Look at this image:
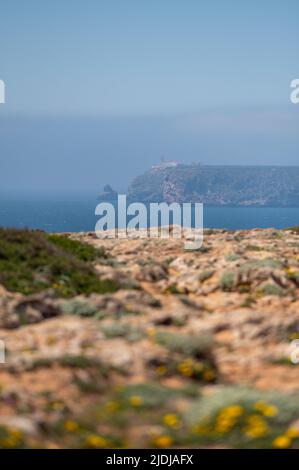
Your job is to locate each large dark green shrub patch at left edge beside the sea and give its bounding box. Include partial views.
[0,228,117,297]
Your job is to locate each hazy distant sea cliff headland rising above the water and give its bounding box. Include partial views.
[128,164,299,207]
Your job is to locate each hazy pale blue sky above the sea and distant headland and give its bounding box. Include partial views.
[0,0,299,193]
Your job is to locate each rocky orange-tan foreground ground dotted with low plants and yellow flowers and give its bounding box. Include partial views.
[0,229,299,448]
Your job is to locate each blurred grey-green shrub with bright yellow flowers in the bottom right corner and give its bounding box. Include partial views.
[185,386,299,448]
